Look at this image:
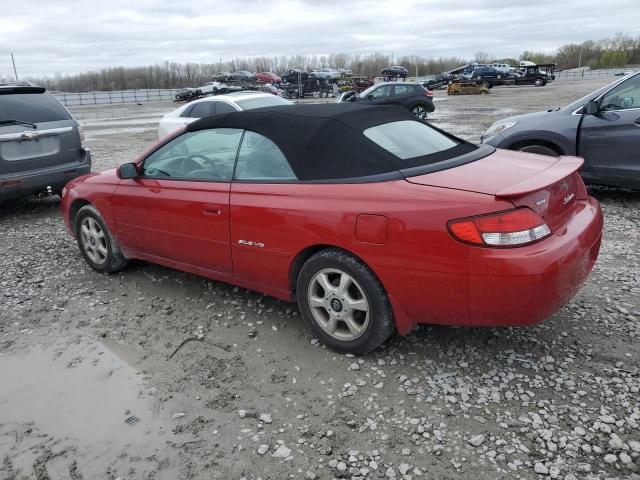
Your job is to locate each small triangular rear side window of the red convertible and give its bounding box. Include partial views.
[235,130,297,182]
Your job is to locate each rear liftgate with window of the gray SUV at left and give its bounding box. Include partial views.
[0,88,81,175]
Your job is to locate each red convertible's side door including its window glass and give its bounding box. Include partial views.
[113,128,243,273]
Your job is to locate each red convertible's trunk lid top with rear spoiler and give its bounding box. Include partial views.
[406,149,583,197]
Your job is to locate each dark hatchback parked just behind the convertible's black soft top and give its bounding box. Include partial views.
[337,82,436,120]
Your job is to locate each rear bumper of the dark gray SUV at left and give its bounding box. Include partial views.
[0,149,91,202]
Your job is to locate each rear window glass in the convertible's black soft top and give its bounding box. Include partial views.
[363,120,461,160]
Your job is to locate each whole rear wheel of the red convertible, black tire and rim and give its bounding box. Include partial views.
[296,248,394,354]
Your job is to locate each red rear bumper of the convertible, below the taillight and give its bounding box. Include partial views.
[468,197,603,326]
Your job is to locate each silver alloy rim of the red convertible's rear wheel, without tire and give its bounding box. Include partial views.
[307,268,370,341]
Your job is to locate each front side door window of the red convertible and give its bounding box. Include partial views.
[143,129,242,182]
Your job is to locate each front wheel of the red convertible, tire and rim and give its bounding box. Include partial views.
[75,205,127,273]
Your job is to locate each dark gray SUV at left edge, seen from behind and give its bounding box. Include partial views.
[0,84,91,202]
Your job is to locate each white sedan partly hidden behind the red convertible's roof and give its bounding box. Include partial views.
[158,92,293,138]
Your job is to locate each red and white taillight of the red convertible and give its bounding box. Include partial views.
[447,208,551,247]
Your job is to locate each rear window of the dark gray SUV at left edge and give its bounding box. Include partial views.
[0,93,71,123]
